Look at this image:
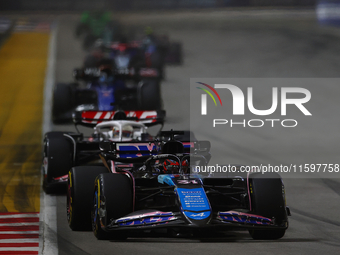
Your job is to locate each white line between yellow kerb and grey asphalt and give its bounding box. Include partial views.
[39,18,58,255]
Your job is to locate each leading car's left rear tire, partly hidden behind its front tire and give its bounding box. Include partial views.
[66,166,108,230]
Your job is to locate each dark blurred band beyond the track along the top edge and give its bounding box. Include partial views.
[0,0,318,11]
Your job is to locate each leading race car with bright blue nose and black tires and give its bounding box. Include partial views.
[67,131,290,239]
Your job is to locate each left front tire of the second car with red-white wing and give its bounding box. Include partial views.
[43,132,73,194]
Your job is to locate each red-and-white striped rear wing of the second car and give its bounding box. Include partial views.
[73,110,166,127]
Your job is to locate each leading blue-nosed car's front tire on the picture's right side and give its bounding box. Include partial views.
[249,173,288,240]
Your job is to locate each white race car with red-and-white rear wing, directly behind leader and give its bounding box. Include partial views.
[42,111,165,193]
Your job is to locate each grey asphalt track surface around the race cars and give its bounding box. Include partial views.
[49,10,340,255]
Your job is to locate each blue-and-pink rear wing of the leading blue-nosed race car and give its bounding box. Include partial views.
[99,141,210,159]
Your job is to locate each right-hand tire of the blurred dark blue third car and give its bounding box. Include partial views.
[140,79,162,110]
